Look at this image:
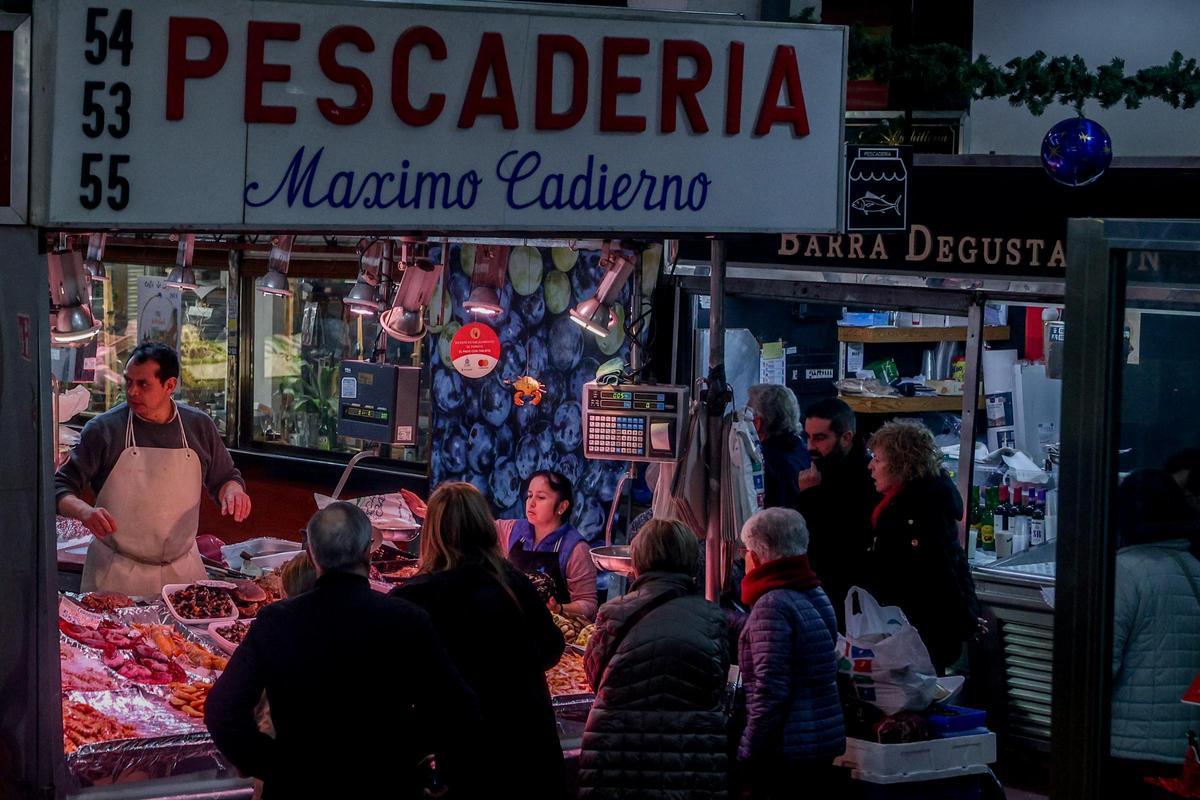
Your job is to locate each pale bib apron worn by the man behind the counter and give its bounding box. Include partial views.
[82,407,205,595]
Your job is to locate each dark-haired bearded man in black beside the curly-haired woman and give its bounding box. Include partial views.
[797,397,880,631]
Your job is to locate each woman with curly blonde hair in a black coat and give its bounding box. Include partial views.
[865,420,979,673]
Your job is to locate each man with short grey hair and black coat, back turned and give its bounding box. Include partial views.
[204,503,479,800]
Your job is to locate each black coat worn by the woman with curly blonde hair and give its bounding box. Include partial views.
[866,473,979,673]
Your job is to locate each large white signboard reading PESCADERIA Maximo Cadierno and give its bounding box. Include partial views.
[35,0,846,234]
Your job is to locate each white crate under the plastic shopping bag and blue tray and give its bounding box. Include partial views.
[834,732,996,780]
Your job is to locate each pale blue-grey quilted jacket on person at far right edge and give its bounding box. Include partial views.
[1111,539,1200,764]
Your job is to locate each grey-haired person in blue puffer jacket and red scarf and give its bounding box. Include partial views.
[738,509,846,800]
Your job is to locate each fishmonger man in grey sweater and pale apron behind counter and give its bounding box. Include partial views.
[54,342,250,595]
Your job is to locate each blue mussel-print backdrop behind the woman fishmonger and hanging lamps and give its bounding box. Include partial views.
[430,245,662,540]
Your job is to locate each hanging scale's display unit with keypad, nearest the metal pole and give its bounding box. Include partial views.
[582,383,688,461]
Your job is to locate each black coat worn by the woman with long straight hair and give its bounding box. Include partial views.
[392,565,566,800]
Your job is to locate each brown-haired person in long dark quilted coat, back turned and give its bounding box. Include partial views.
[578,519,730,800]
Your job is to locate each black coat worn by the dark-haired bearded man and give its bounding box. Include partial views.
[797,441,880,631]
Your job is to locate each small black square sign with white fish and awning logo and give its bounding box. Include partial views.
[846,144,912,231]
